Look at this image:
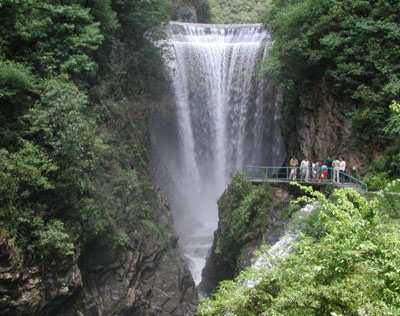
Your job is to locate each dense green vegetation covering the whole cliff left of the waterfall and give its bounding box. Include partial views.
[0,0,177,268]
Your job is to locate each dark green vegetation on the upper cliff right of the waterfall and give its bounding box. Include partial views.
[265,0,400,178]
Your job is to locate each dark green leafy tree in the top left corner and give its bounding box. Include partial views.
[0,0,103,75]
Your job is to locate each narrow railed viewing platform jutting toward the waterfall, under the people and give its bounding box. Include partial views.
[243,166,368,191]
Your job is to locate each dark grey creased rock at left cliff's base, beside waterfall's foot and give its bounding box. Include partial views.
[71,231,197,316]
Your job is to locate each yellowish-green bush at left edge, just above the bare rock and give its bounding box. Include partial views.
[0,140,74,263]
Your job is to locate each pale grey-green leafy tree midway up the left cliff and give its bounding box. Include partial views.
[24,79,96,212]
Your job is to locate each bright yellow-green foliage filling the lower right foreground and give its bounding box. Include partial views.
[197,181,400,316]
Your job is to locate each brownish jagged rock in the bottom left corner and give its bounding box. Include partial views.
[0,239,82,316]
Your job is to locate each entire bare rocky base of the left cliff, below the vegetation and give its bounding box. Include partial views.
[0,192,197,316]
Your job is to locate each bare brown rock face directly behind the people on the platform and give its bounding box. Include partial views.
[285,82,362,175]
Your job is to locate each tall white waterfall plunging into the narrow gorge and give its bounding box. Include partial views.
[155,22,285,284]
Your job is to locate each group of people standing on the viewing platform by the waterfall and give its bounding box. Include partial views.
[289,156,346,183]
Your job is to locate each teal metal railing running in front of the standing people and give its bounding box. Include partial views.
[244,166,368,191]
